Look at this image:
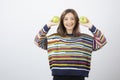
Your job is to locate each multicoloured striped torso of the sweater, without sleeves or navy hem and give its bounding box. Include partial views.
[47,34,93,76]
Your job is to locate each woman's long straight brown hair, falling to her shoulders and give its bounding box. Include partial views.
[57,9,80,37]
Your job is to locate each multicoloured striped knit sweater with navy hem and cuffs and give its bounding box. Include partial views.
[35,25,106,77]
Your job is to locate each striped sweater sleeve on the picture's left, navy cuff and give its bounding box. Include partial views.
[34,25,50,50]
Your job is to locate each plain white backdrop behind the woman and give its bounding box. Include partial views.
[0,0,120,80]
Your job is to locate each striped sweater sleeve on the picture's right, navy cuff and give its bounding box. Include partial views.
[89,25,107,51]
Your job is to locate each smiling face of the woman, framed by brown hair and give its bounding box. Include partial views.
[63,13,76,31]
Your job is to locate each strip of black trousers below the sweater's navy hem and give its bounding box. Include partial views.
[53,76,85,80]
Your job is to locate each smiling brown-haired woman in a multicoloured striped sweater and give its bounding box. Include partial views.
[35,9,106,80]
